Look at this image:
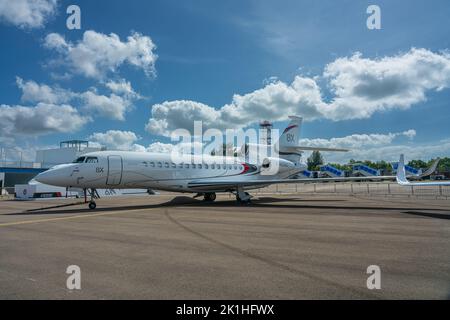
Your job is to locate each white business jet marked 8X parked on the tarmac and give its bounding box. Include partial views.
[35,117,395,209]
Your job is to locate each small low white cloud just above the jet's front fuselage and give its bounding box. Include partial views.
[88,130,139,150]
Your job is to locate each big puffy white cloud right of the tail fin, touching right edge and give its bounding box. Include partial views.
[323,49,450,120]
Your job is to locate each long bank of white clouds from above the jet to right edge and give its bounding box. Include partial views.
[146,49,450,136]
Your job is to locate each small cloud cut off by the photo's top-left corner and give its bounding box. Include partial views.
[0,0,57,29]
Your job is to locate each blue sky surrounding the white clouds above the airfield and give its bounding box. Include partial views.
[0,0,450,161]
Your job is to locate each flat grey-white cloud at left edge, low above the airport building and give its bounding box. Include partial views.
[0,103,90,137]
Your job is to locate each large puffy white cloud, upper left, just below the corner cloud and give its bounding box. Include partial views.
[44,30,158,79]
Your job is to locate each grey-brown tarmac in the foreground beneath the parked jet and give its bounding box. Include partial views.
[0,194,450,299]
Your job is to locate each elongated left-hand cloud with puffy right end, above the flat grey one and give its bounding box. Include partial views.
[17,77,141,121]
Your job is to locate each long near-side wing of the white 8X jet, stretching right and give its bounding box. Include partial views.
[188,176,395,189]
